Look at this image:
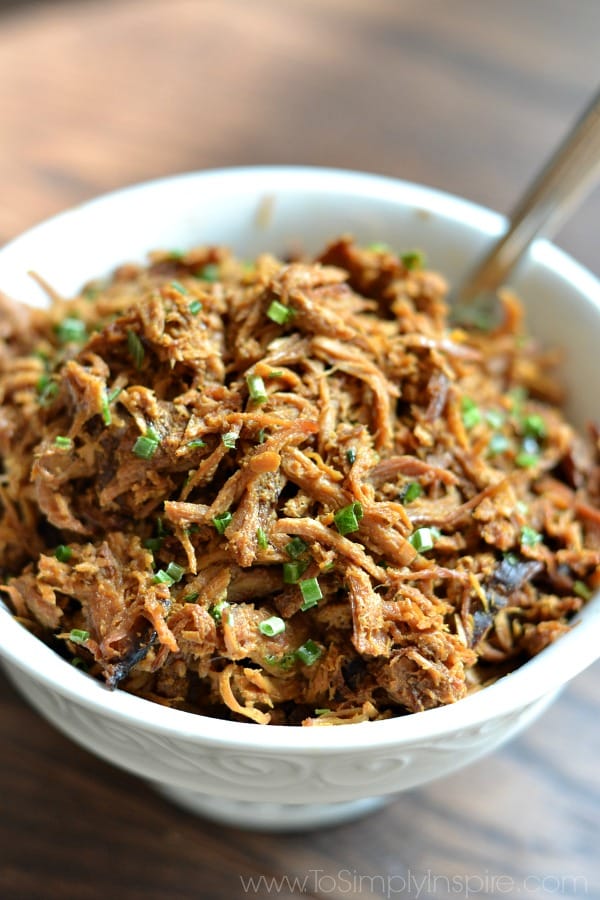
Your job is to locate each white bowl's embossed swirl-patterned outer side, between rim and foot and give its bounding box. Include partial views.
[9,669,554,803]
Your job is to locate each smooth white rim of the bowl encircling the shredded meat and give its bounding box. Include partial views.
[0,165,600,755]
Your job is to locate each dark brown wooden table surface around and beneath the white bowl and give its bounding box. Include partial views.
[0,0,600,900]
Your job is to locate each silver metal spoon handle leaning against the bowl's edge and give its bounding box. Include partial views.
[457,92,600,305]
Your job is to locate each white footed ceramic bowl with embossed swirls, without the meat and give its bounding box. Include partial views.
[0,167,600,829]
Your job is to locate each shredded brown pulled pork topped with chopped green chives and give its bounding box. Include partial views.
[0,239,600,726]
